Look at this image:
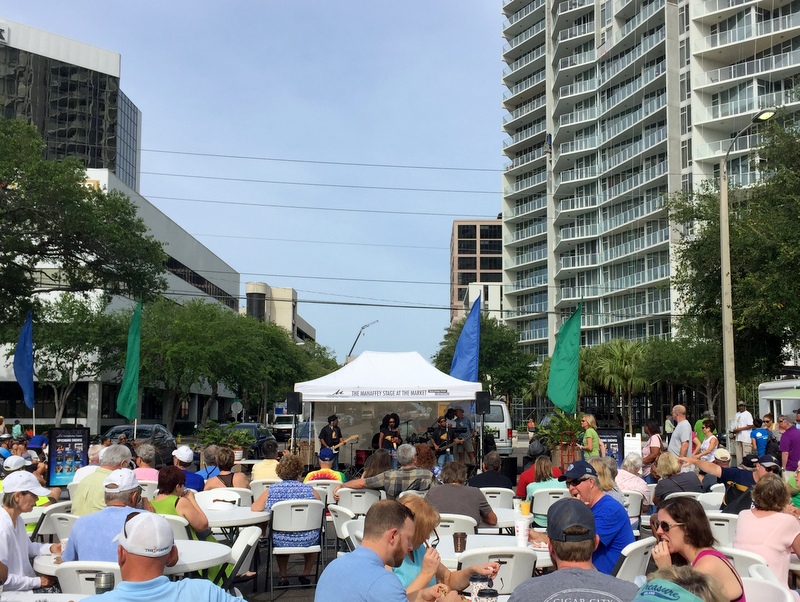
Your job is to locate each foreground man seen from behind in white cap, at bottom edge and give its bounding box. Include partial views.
[86,512,242,602]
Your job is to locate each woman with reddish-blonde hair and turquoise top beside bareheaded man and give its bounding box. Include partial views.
[392,495,500,594]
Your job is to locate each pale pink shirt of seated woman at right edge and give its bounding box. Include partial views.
[733,510,800,600]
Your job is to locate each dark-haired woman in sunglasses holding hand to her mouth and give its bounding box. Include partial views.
[652,497,745,602]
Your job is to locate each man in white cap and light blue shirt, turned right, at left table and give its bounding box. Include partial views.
[61,468,153,562]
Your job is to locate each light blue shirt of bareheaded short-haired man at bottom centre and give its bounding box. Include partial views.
[318,544,410,602]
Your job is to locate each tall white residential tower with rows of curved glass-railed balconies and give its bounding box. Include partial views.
[503,0,800,357]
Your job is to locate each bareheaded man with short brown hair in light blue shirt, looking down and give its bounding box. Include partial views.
[314,500,461,602]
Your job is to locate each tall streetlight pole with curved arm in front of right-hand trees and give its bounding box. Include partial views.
[719,109,776,424]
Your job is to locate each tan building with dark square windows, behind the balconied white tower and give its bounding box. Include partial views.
[450,219,503,324]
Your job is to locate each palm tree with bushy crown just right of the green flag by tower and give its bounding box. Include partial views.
[597,339,647,432]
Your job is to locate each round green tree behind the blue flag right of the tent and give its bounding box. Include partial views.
[432,314,536,401]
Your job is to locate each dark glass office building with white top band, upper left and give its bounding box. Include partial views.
[0,19,141,192]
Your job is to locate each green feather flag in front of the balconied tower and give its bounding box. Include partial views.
[547,301,583,414]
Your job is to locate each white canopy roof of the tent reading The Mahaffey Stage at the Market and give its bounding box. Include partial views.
[294,351,482,402]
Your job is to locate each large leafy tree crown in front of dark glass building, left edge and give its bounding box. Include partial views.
[0,118,166,322]
